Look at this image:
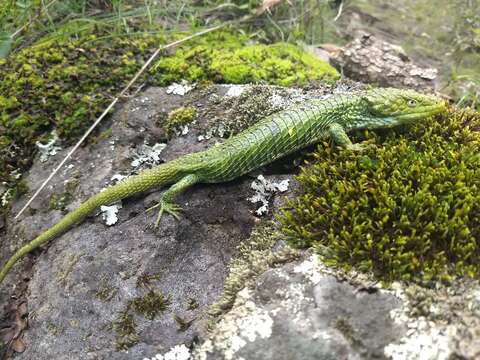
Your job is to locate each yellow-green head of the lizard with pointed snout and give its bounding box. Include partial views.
[362,88,446,127]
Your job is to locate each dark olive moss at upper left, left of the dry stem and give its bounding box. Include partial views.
[0,34,164,187]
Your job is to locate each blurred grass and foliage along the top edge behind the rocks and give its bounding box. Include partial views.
[0,0,480,108]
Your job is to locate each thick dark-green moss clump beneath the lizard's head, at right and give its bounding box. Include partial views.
[279,111,480,282]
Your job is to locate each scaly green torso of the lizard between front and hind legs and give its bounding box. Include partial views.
[198,95,348,183]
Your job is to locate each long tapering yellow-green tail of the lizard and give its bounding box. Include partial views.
[0,160,183,283]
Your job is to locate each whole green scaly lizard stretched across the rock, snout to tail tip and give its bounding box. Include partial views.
[0,88,446,282]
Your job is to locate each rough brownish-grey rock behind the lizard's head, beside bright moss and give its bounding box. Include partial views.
[331,33,438,91]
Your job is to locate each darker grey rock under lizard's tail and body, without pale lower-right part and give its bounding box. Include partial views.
[0,86,322,360]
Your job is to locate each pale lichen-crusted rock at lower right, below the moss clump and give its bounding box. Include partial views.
[191,252,480,360]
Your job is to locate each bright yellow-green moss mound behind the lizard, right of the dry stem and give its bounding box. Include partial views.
[152,31,339,86]
